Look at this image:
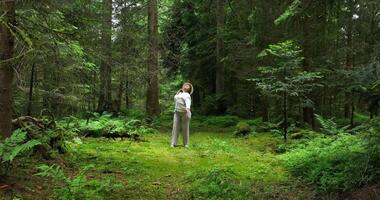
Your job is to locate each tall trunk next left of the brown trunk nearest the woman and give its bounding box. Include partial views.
[98,0,112,112]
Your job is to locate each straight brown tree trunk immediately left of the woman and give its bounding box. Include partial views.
[146,0,160,117]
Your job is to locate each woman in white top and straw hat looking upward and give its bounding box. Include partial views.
[171,83,193,148]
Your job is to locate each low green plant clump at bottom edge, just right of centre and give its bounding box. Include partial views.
[187,168,249,199]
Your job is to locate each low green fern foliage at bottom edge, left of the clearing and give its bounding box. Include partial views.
[36,165,123,200]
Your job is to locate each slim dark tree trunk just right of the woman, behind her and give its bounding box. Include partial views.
[215,0,225,94]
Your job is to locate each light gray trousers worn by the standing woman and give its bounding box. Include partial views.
[172,111,191,145]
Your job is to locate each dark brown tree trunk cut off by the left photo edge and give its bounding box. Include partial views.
[0,1,16,139]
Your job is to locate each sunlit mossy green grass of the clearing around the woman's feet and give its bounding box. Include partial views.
[65,132,314,199]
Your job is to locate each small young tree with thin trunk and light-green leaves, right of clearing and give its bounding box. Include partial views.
[250,40,321,141]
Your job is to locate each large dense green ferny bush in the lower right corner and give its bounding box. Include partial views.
[283,134,380,193]
